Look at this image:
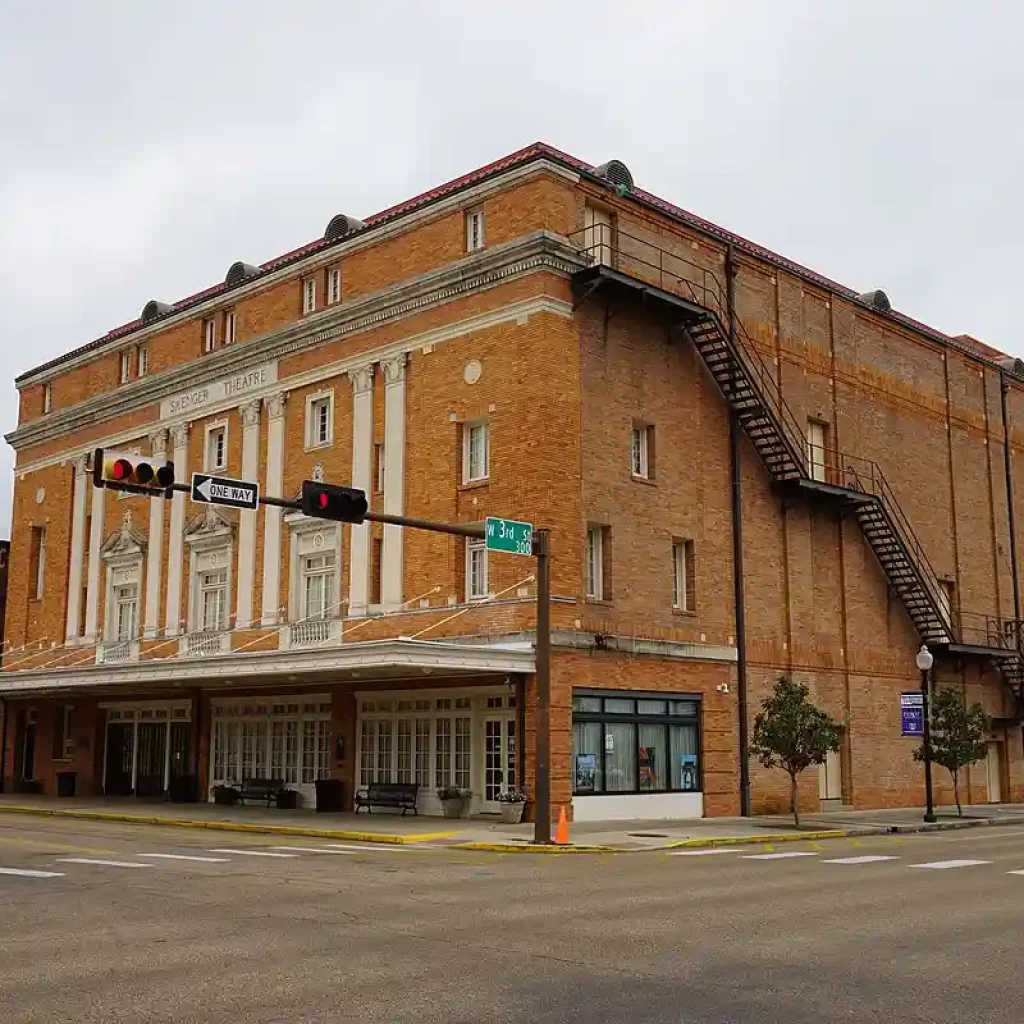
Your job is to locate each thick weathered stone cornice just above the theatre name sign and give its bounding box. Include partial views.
[5,231,589,450]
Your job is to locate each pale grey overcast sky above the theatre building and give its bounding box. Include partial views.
[0,0,1024,536]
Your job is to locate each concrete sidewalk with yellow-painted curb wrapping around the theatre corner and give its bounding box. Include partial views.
[0,795,1024,853]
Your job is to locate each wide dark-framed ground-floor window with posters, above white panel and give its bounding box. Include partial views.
[572,693,700,796]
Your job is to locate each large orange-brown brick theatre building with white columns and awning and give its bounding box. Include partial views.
[0,144,1024,820]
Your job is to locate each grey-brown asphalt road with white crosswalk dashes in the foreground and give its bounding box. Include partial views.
[0,816,1024,1024]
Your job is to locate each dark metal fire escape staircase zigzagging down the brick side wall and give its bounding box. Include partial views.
[573,229,1024,702]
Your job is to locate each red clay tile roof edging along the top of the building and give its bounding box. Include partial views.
[14,142,1009,384]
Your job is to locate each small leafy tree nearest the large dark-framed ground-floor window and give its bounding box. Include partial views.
[750,676,840,827]
